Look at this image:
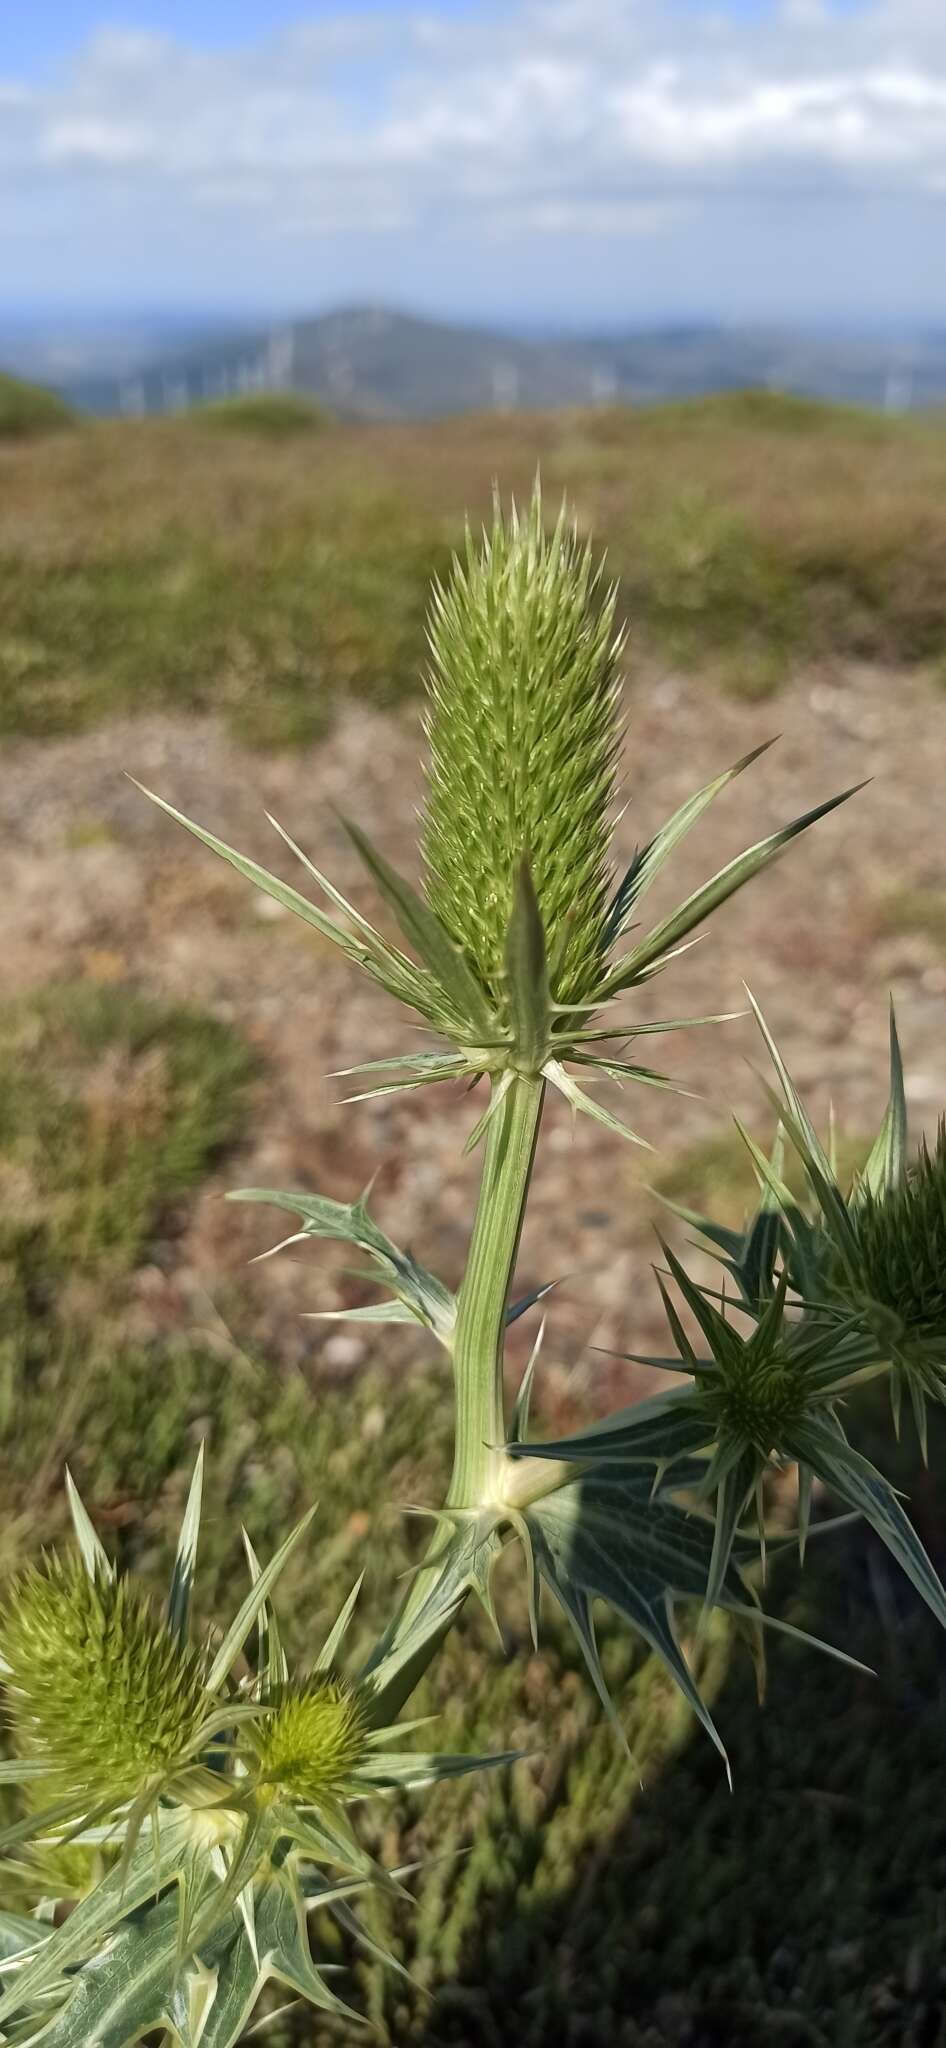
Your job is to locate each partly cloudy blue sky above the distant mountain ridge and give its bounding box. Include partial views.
[0,0,946,328]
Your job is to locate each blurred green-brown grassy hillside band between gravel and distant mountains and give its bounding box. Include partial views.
[0,393,946,745]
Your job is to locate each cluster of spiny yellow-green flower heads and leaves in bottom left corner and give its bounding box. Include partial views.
[0,1458,513,2048]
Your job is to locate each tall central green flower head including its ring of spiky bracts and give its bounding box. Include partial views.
[138,483,852,1143]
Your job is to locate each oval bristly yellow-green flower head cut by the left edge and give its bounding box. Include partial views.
[0,1556,207,1806]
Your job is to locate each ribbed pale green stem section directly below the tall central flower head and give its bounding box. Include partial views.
[446,1075,545,1507]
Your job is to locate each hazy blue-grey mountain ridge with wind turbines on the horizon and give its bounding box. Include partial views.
[24,305,946,420]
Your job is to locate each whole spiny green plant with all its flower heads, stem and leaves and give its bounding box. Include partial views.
[0,471,946,2048]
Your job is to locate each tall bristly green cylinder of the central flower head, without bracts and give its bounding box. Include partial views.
[424,485,620,1004]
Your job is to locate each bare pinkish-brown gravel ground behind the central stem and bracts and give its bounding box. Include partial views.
[0,666,946,1419]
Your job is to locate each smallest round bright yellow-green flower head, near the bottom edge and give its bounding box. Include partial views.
[250,1677,369,1806]
